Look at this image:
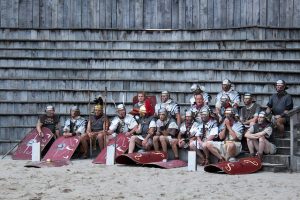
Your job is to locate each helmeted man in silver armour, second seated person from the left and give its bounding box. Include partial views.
[63,106,88,158]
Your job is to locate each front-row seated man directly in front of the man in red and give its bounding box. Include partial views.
[128,105,156,153]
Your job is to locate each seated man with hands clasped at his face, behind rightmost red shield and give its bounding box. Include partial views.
[206,108,244,162]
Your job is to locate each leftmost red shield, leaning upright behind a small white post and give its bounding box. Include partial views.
[12,127,53,160]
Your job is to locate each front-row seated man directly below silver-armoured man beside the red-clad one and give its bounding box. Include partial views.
[153,108,179,159]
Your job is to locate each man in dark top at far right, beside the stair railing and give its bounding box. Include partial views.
[266,80,294,137]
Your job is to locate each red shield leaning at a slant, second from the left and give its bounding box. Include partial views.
[42,136,80,161]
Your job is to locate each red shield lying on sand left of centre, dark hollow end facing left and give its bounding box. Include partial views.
[116,151,167,165]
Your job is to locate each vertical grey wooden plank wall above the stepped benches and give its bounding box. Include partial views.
[0,0,300,29]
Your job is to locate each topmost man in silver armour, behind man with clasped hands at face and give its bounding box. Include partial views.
[216,79,240,112]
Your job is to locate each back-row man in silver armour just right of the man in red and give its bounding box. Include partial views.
[155,91,181,127]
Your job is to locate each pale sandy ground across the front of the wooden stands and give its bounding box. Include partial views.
[0,157,300,200]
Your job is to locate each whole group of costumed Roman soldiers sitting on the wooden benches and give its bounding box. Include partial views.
[36,79,293,165]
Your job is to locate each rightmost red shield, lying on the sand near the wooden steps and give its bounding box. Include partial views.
[204,157,261,175]
